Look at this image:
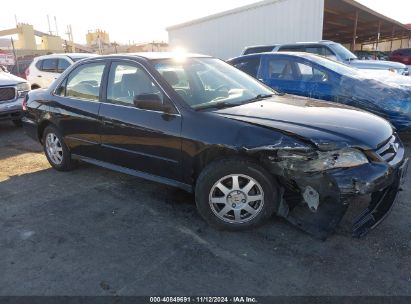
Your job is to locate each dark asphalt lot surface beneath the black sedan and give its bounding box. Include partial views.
[0,123,411,296]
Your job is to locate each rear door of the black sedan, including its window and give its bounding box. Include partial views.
[50,60,106,159]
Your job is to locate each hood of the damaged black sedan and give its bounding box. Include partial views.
[214,95,393,150]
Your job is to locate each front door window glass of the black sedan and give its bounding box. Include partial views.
[107,62,163,106]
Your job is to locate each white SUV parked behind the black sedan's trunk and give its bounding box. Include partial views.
[25,53,97,90]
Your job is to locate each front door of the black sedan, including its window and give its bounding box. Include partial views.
[100,60,182,180]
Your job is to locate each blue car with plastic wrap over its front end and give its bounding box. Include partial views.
[228,53,411,131]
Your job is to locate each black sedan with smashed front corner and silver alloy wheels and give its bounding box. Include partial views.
[23,53,407,239]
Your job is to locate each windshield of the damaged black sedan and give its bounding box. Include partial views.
[153,58,275,109]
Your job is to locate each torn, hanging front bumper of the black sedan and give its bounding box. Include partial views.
[268,141,408,240]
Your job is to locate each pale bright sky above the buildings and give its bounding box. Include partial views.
[0,0,411,43]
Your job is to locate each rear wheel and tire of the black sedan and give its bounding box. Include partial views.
[42,126,75,171]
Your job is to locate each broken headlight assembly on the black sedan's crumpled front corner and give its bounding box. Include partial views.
[270,148,368,173]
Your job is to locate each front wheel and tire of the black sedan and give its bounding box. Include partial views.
[195,159,280,231]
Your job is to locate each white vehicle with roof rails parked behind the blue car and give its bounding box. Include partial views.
[243,40,409,75]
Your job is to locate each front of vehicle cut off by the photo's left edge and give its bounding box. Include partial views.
[0,69,30,126]
